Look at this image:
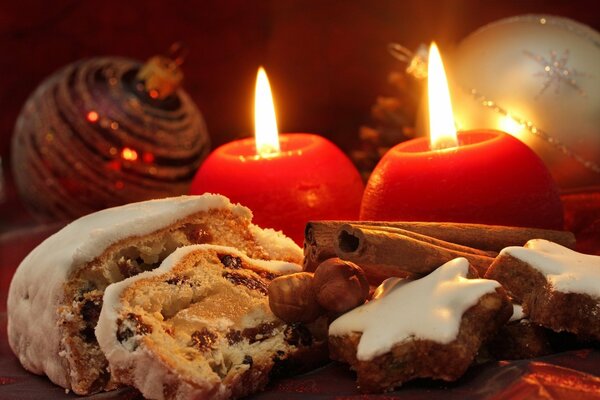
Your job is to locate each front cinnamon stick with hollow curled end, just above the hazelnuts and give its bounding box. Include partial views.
[335,224,494,276]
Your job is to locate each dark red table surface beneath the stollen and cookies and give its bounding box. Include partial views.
[0,224,600,400]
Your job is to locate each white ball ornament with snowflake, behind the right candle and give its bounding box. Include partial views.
[448,15,600,191]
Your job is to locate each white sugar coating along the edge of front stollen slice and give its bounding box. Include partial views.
[96,244,302,398]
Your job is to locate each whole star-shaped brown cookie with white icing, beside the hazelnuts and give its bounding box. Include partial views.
[329,258,512,392]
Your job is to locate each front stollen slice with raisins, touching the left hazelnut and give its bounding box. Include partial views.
[96,245,327,400]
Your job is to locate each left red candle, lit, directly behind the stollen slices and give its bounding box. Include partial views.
[191,68,364,244]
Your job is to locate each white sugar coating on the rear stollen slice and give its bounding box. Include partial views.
[7,194,302,387]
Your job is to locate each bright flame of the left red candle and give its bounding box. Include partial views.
[254,67,280,156]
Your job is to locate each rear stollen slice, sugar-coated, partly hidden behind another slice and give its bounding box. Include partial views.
[7,194,302,394]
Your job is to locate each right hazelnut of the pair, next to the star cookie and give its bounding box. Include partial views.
[313,258,369,313]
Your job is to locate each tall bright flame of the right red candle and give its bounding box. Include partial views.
[427,42,458,150]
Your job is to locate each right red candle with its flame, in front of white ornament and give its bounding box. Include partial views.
[360,42,563,229]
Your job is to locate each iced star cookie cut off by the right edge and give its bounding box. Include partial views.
[486,239,600,341]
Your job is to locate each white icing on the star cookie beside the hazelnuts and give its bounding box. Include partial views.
[329,258,500,361]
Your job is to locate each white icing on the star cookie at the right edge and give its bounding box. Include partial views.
[500,239,600,297]
